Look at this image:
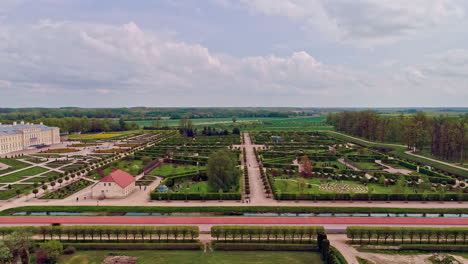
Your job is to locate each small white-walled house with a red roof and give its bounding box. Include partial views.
[91,169,135,198]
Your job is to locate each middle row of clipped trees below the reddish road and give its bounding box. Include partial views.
[211,226,325,242]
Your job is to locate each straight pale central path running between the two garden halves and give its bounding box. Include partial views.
[243,133,275,205]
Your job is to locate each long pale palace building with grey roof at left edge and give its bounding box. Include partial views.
[0,122,60,154]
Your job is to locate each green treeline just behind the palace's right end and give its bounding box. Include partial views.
[37,117,139,133]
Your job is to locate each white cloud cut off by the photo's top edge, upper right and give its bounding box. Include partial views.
[215,0,464,47]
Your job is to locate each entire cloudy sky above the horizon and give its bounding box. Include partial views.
[0,0,468,107]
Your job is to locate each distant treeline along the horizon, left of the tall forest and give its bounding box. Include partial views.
[0,107,317,121]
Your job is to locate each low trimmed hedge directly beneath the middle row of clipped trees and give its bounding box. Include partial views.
[213,241,317,251]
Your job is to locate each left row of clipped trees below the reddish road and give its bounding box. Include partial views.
[0,226,200,241]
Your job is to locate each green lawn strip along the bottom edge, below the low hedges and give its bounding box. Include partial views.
[58,250,323,264]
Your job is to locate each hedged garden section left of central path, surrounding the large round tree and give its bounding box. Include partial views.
[140,135,242,200]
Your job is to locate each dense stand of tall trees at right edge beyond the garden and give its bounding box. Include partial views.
[327,111,468,163]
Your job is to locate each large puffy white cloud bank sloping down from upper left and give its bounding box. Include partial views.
[0,21,374,101]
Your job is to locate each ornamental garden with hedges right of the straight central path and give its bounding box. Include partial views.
[252,131,468,201]
